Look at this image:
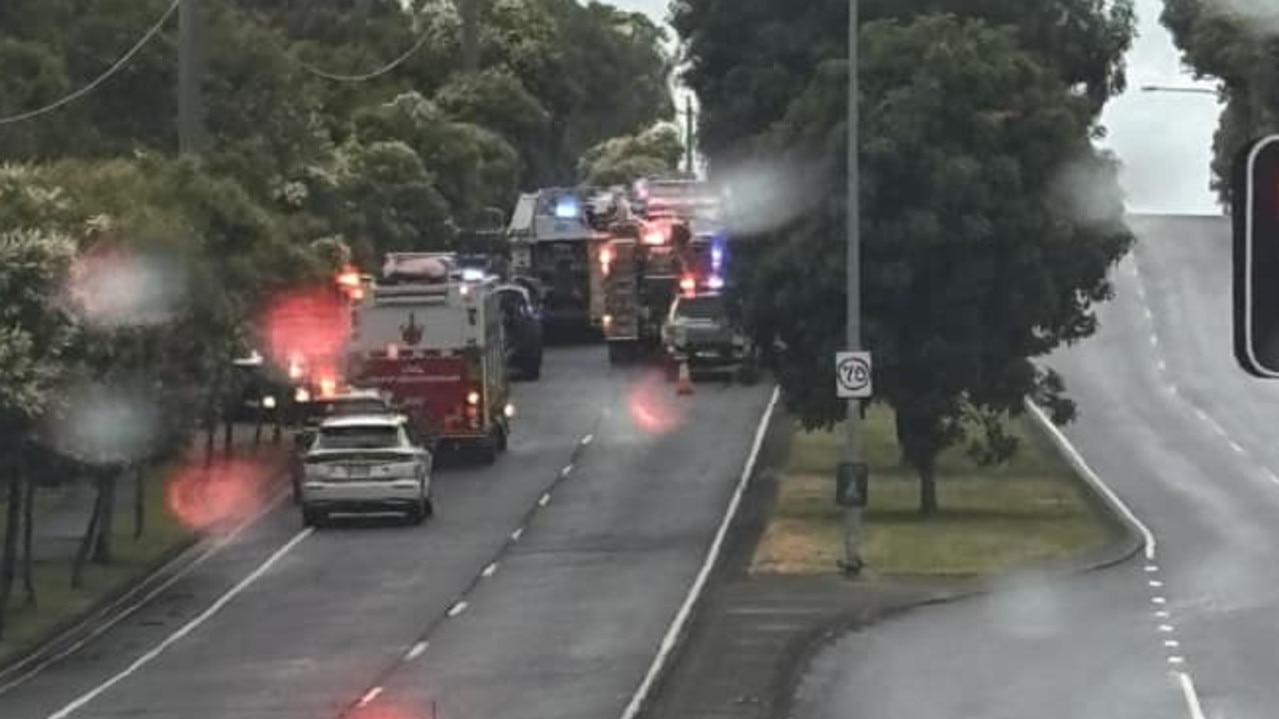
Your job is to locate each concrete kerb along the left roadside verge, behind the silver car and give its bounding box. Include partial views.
[0,447,288,695]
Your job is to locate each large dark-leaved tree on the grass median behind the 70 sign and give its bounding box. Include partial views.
[735,15,1131,513]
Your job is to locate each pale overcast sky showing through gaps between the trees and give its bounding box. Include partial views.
[614,0,1220,214]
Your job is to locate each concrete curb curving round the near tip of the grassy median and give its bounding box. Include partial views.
[770,399,1152,718]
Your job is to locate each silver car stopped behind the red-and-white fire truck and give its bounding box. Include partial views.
[301,415,435,526]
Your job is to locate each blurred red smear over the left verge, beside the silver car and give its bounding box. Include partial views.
[165,459,270,531]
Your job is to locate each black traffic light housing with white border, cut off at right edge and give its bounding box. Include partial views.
[1232,134,1279,379]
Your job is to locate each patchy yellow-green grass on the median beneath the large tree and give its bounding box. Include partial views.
[752,409,1115,577]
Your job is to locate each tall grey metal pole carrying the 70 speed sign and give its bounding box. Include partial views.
[843,0,862,573]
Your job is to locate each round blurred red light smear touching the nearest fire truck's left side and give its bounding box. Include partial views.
[260,288,350,376]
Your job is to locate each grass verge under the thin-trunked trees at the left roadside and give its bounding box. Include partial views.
[0,471,189,663]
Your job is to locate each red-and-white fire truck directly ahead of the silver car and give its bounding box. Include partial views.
[347,252,514,462]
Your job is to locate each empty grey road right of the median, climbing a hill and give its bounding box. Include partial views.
[794,216,1279,719]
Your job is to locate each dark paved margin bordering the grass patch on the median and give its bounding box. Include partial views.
[643,399,1146,719]
